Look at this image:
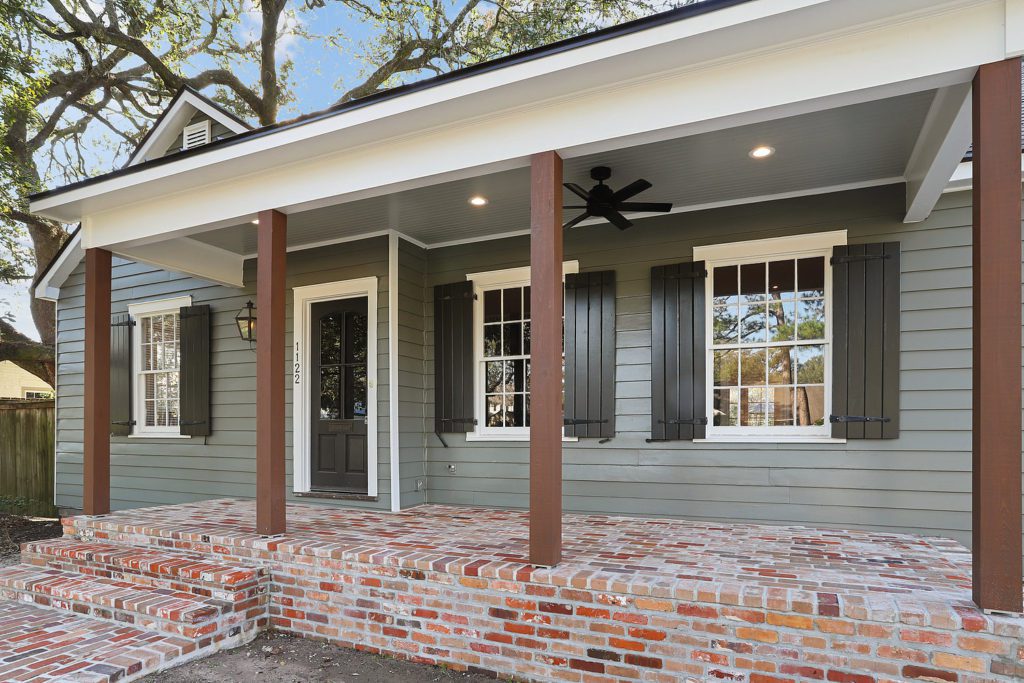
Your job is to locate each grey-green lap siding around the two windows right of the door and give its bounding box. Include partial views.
[424,186,1019,541]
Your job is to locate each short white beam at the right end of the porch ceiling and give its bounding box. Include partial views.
[903,83,972,223]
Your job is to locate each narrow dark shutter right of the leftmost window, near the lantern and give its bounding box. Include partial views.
[178,305,211,436]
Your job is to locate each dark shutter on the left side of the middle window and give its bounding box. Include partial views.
[434,281,475,434]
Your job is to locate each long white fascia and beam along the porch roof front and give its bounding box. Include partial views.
[33,0,1004,246]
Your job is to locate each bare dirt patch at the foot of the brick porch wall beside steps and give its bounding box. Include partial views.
[140,632,494,683]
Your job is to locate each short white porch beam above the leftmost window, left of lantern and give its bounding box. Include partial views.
[115,238,245,287]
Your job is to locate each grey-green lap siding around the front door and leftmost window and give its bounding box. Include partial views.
[56,239,390,509]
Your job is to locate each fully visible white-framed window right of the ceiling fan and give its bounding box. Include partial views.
[694,232,845,438]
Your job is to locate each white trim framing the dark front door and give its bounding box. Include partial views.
[291,276,380,498]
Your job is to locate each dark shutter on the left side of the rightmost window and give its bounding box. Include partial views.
[650,261,708,441]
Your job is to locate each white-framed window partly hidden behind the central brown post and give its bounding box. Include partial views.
[467,261,580,440]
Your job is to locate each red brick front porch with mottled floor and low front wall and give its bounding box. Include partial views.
[0,500,1024,683]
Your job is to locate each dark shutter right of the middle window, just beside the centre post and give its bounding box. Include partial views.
[565,270,615,438]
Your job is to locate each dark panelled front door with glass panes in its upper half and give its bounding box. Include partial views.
[309,297,368,494]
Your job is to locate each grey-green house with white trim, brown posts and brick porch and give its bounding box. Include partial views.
[9,0,1024,681]
